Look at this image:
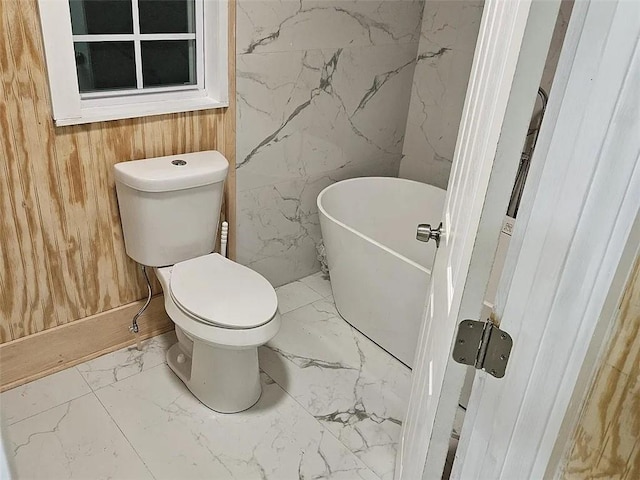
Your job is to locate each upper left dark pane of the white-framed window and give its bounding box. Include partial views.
[69,0,133,35]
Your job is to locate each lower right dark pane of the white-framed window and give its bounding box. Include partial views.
[142,40,196,87]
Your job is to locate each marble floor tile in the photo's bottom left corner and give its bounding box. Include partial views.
[5,393,153,480]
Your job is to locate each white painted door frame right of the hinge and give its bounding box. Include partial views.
[452,0,640,480]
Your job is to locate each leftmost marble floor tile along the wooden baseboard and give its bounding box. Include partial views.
[0,368,91,425]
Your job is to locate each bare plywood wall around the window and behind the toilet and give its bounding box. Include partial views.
[0,0,235,343]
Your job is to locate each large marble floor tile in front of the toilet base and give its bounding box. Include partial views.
[96,365,376,480]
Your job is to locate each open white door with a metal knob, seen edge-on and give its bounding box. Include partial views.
[395,0,559,480]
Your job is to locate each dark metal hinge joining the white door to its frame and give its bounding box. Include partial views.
[453,320,513,378]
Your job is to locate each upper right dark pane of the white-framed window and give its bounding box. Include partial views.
[138,0,195,33]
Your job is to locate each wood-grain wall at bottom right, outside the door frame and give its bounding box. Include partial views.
[564,253,640,480]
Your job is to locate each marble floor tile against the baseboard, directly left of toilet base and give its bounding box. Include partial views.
[76,331,177,390]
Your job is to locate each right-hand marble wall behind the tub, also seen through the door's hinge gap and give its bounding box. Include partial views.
[400,0,573,188]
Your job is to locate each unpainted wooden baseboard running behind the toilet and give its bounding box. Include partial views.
[0,295,173,392]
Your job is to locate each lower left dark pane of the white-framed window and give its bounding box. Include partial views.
[74,42,136,92]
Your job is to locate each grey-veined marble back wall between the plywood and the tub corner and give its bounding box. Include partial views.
[236,0,423,286]
